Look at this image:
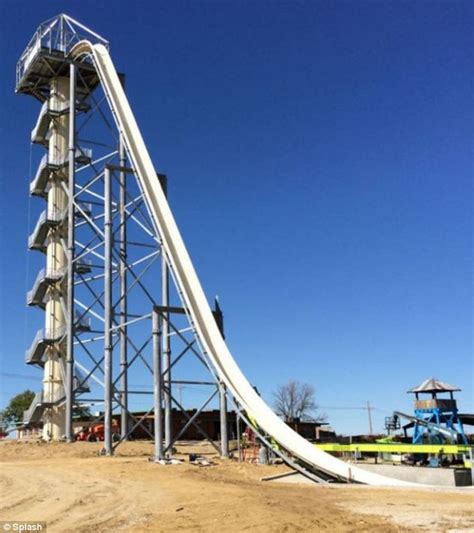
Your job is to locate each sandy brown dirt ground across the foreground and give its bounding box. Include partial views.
[0,441,474,533]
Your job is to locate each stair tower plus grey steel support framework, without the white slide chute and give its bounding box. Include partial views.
[16,15,229,454]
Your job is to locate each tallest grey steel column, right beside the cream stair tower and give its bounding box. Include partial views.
[65,63,76,442]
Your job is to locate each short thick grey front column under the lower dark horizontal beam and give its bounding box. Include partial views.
[152,309,164,462]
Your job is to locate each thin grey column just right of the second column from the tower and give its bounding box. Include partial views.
[119,135,129,440]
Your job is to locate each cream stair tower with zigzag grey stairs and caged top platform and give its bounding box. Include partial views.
[16,15,107,440]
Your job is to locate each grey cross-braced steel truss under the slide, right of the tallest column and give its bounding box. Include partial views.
[67,155,228,459]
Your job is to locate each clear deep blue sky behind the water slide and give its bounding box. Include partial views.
[0,0,474,432]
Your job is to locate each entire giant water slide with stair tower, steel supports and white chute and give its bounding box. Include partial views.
[16,15,470,486]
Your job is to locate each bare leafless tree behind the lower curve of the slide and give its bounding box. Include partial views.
[273,380,326,422]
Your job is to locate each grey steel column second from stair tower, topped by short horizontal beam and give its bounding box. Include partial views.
[104,168,113,455]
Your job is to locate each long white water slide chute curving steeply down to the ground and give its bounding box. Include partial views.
[71,41,419,486]
